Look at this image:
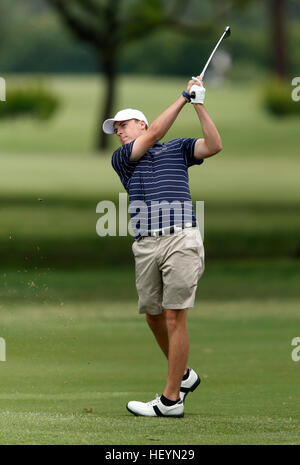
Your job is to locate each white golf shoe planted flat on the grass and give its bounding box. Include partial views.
[126,394,184,418]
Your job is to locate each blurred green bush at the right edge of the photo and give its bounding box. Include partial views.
[262,78,300,117]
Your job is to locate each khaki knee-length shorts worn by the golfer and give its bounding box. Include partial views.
[132,227,204,315]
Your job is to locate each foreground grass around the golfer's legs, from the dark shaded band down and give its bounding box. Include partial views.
[0,261,300,444]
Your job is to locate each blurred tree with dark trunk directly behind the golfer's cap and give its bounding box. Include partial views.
[48,0,216,150]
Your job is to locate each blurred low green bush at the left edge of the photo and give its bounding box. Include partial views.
[0,84,59,120]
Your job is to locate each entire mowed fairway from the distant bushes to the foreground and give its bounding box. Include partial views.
[0,76,300,445]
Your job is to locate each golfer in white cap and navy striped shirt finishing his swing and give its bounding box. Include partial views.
[103,76,222,417]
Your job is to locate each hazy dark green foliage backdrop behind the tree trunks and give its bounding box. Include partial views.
[0,0,300,79]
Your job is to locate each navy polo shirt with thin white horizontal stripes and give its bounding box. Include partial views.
[112,138,203,239]
